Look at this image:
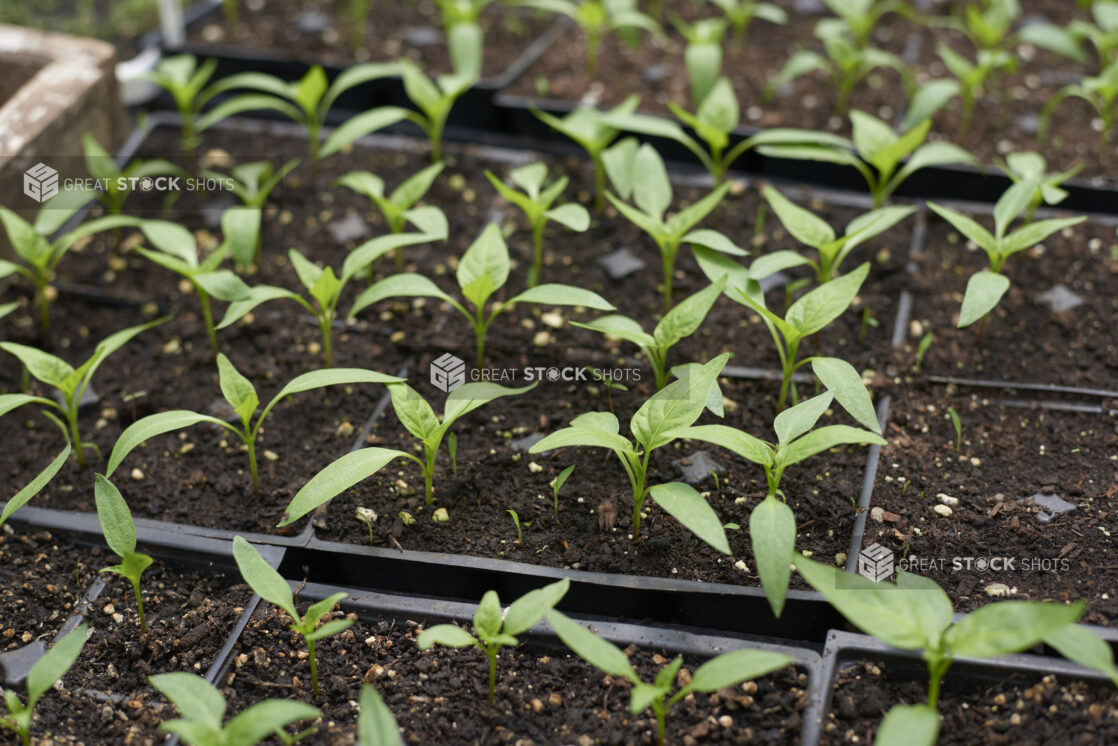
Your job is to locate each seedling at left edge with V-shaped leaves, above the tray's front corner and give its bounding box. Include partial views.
[0,318,170,469]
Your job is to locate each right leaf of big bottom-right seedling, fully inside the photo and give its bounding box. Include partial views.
[944,601,1086,658]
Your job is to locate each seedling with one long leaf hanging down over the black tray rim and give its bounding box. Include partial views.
[669,389,885,616]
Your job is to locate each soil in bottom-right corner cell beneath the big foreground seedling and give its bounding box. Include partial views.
[822,662,1118,746]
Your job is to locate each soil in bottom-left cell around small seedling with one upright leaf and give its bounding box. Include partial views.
[31,553,253,744]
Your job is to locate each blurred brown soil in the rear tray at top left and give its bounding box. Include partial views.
[188,0,550,77]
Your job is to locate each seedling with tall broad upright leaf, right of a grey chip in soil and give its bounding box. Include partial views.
[603,138,746,313]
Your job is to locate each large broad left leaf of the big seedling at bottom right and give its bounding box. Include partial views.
[795,556,953,650]
